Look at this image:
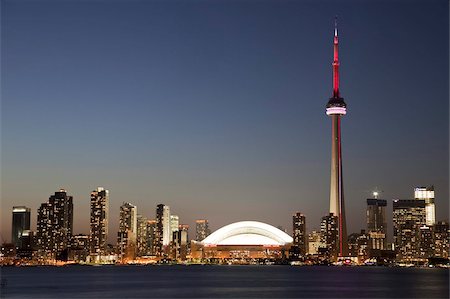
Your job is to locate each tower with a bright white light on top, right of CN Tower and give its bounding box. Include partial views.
[366,198,387,250]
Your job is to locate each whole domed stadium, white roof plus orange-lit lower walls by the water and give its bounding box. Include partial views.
[191,221,293,261]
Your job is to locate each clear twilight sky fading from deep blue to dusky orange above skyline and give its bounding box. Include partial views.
[0,0,449,242]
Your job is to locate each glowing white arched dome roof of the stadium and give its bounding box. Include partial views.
[201,221,293,246]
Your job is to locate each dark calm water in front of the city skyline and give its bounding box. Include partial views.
[1,266,449,298]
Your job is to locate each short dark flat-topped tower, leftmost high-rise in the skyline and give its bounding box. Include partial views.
[11,206,31,249]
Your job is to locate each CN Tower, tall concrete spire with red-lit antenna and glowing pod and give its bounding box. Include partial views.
[327,20,348,257]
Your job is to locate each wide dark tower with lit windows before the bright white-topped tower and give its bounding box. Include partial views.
[393,199,425,262]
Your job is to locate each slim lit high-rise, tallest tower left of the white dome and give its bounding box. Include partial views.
[90,187,109,263]
